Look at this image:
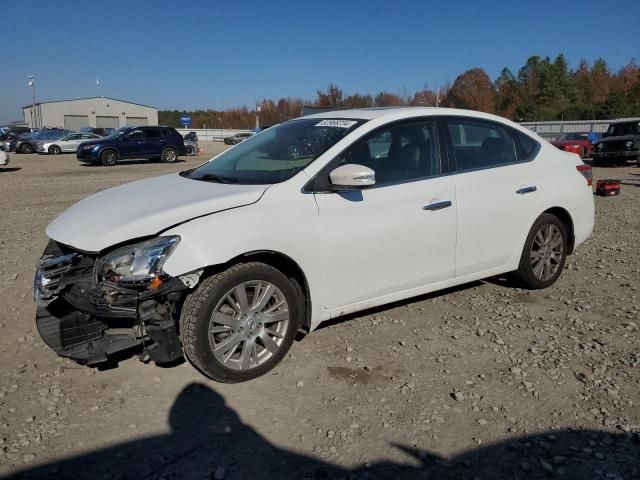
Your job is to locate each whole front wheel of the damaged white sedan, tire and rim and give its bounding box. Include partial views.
[180,262,303,383]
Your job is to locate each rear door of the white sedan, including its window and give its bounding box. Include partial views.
[446,117,542,277]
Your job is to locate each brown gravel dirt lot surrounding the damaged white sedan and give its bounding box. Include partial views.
[0,145,640,480]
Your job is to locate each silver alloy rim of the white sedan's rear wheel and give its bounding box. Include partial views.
[529,223,564,282]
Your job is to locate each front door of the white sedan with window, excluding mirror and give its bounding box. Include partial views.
[313,120,456,309]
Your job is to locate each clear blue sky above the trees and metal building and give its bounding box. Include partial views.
[0,0,640,123]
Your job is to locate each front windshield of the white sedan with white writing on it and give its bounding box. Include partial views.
[181,118,364,185]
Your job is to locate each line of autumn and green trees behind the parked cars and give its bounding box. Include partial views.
[158,54,640,128]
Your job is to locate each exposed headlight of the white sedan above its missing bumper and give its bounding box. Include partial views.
[95,236,180,288]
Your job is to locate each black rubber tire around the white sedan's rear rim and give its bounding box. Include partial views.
[515,213,569,290]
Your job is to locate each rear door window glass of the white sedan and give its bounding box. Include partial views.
[447,119,517,170]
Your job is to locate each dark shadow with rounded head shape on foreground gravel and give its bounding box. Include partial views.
[11,384,640,480]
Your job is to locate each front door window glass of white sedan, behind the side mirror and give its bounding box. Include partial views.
[334,120,441,185]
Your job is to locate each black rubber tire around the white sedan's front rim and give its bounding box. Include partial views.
[180,262,304,383]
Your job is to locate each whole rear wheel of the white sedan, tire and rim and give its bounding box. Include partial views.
[517,213,568,289]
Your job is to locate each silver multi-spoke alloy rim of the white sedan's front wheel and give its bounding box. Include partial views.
[209,280,289,371]
